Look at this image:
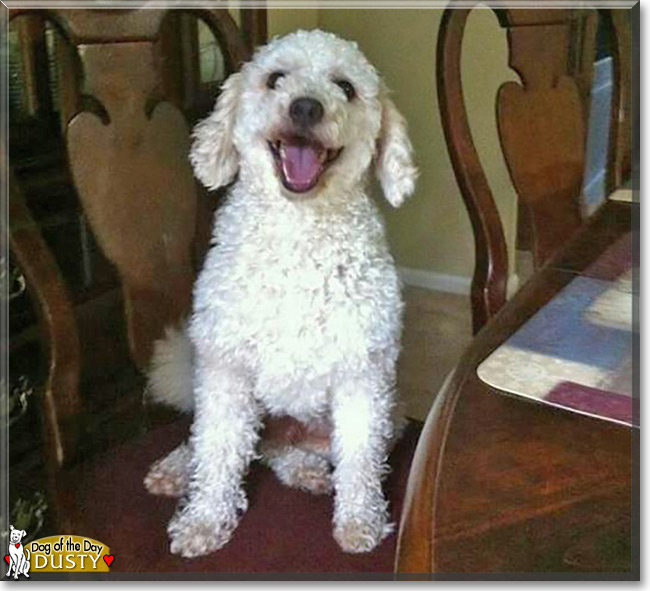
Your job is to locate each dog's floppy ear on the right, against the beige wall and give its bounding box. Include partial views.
[376,88,418,207]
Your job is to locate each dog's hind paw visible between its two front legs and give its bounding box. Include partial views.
[262,446,332,495]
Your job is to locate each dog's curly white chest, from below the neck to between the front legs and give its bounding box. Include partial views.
[192,205,402,420]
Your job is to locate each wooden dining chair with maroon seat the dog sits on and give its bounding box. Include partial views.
[10,9,418,577]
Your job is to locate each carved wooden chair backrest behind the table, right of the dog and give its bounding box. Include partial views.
[437,8,629,332]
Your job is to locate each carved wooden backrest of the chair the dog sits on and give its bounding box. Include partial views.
[10,8,248,476]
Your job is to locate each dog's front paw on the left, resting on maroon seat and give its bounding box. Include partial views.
[167,507,237,558]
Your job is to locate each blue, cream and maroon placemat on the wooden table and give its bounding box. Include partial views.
[477,272,638,426]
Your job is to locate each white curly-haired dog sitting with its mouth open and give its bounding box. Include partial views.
[145,31,417,557]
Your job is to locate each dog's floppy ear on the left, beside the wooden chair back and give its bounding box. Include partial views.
[190,72,242,189]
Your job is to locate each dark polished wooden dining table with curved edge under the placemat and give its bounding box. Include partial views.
[395,200,639,580]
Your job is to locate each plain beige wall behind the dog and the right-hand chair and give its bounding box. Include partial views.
[269,9,516,288]
